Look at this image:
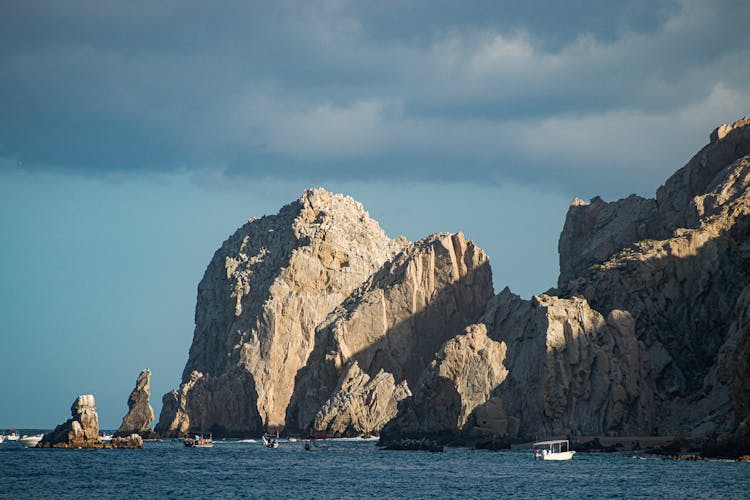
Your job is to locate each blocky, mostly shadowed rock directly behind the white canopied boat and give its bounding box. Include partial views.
[483,289,653,438]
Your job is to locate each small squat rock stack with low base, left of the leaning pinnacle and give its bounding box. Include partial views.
[37,394,143,448]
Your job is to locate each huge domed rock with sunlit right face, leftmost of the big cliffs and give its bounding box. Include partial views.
[156,189,407,436]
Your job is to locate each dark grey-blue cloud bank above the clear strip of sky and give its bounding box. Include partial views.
[0,0,750,194]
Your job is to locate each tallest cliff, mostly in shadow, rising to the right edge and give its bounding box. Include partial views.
[558,119,750,435]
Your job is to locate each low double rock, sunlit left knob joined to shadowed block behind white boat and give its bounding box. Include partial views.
[383,289,652,443]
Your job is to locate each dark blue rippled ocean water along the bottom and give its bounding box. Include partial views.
[0,440,750,499]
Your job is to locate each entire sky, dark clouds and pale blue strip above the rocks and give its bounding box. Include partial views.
[0,0,750,427]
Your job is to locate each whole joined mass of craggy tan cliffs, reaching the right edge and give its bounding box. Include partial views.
[155,119,750,453]
